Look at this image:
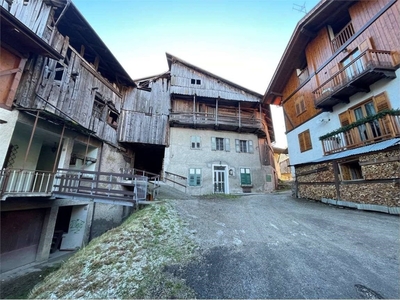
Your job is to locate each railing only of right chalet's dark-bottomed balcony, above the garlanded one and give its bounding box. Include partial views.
[313,49,394,106]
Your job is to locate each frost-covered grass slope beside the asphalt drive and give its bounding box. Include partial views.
[30,203,195,299]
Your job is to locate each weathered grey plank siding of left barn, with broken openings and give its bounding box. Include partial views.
[16,28,122,144]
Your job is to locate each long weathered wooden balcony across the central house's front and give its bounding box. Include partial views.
[169,112,267,135]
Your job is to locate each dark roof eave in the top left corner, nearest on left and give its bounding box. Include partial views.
[0,6,61,59]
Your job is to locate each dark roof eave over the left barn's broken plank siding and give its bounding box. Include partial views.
[53,0,134,85]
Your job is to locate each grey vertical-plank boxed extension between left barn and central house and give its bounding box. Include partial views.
[118,78,171,145]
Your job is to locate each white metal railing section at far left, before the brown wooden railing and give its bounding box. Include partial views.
[0,169,54,199]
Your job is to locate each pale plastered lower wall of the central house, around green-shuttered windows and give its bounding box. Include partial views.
[164,127,273,195]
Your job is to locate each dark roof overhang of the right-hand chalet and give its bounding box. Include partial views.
[263,0,357,105]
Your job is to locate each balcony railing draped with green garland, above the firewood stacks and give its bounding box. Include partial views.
[320,111,400,155]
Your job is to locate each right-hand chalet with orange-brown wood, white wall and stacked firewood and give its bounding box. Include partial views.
[263,0,400,214]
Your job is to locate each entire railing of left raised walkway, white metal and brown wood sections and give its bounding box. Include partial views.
[0,169,160,206]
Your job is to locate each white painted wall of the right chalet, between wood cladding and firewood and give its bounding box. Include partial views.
[287,69,400,165]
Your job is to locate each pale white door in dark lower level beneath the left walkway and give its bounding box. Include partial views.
[60,205,88,250]
